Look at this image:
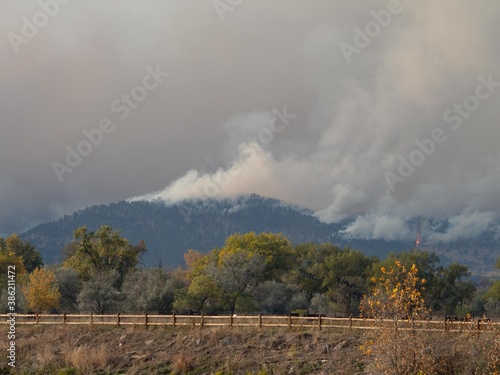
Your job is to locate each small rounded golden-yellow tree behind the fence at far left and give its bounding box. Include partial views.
[22,268,61,313]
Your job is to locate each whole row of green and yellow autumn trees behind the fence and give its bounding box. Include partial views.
[0,225,500,316]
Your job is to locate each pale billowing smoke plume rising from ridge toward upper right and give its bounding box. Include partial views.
[130,2,500,241]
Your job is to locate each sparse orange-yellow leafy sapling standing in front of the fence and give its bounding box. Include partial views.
[360,260,434,375]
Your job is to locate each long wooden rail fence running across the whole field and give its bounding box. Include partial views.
[0,314,500,332]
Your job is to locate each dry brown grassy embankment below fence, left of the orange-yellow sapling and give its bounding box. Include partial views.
[0,326,363,375]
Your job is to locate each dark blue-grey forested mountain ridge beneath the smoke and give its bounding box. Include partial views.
[21,195,500,272]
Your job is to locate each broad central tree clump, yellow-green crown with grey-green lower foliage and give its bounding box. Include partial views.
[175,232,292,312]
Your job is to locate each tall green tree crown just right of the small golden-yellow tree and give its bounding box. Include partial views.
[64,225,146,288]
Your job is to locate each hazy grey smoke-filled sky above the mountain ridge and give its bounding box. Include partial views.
[0,0,500,240]
